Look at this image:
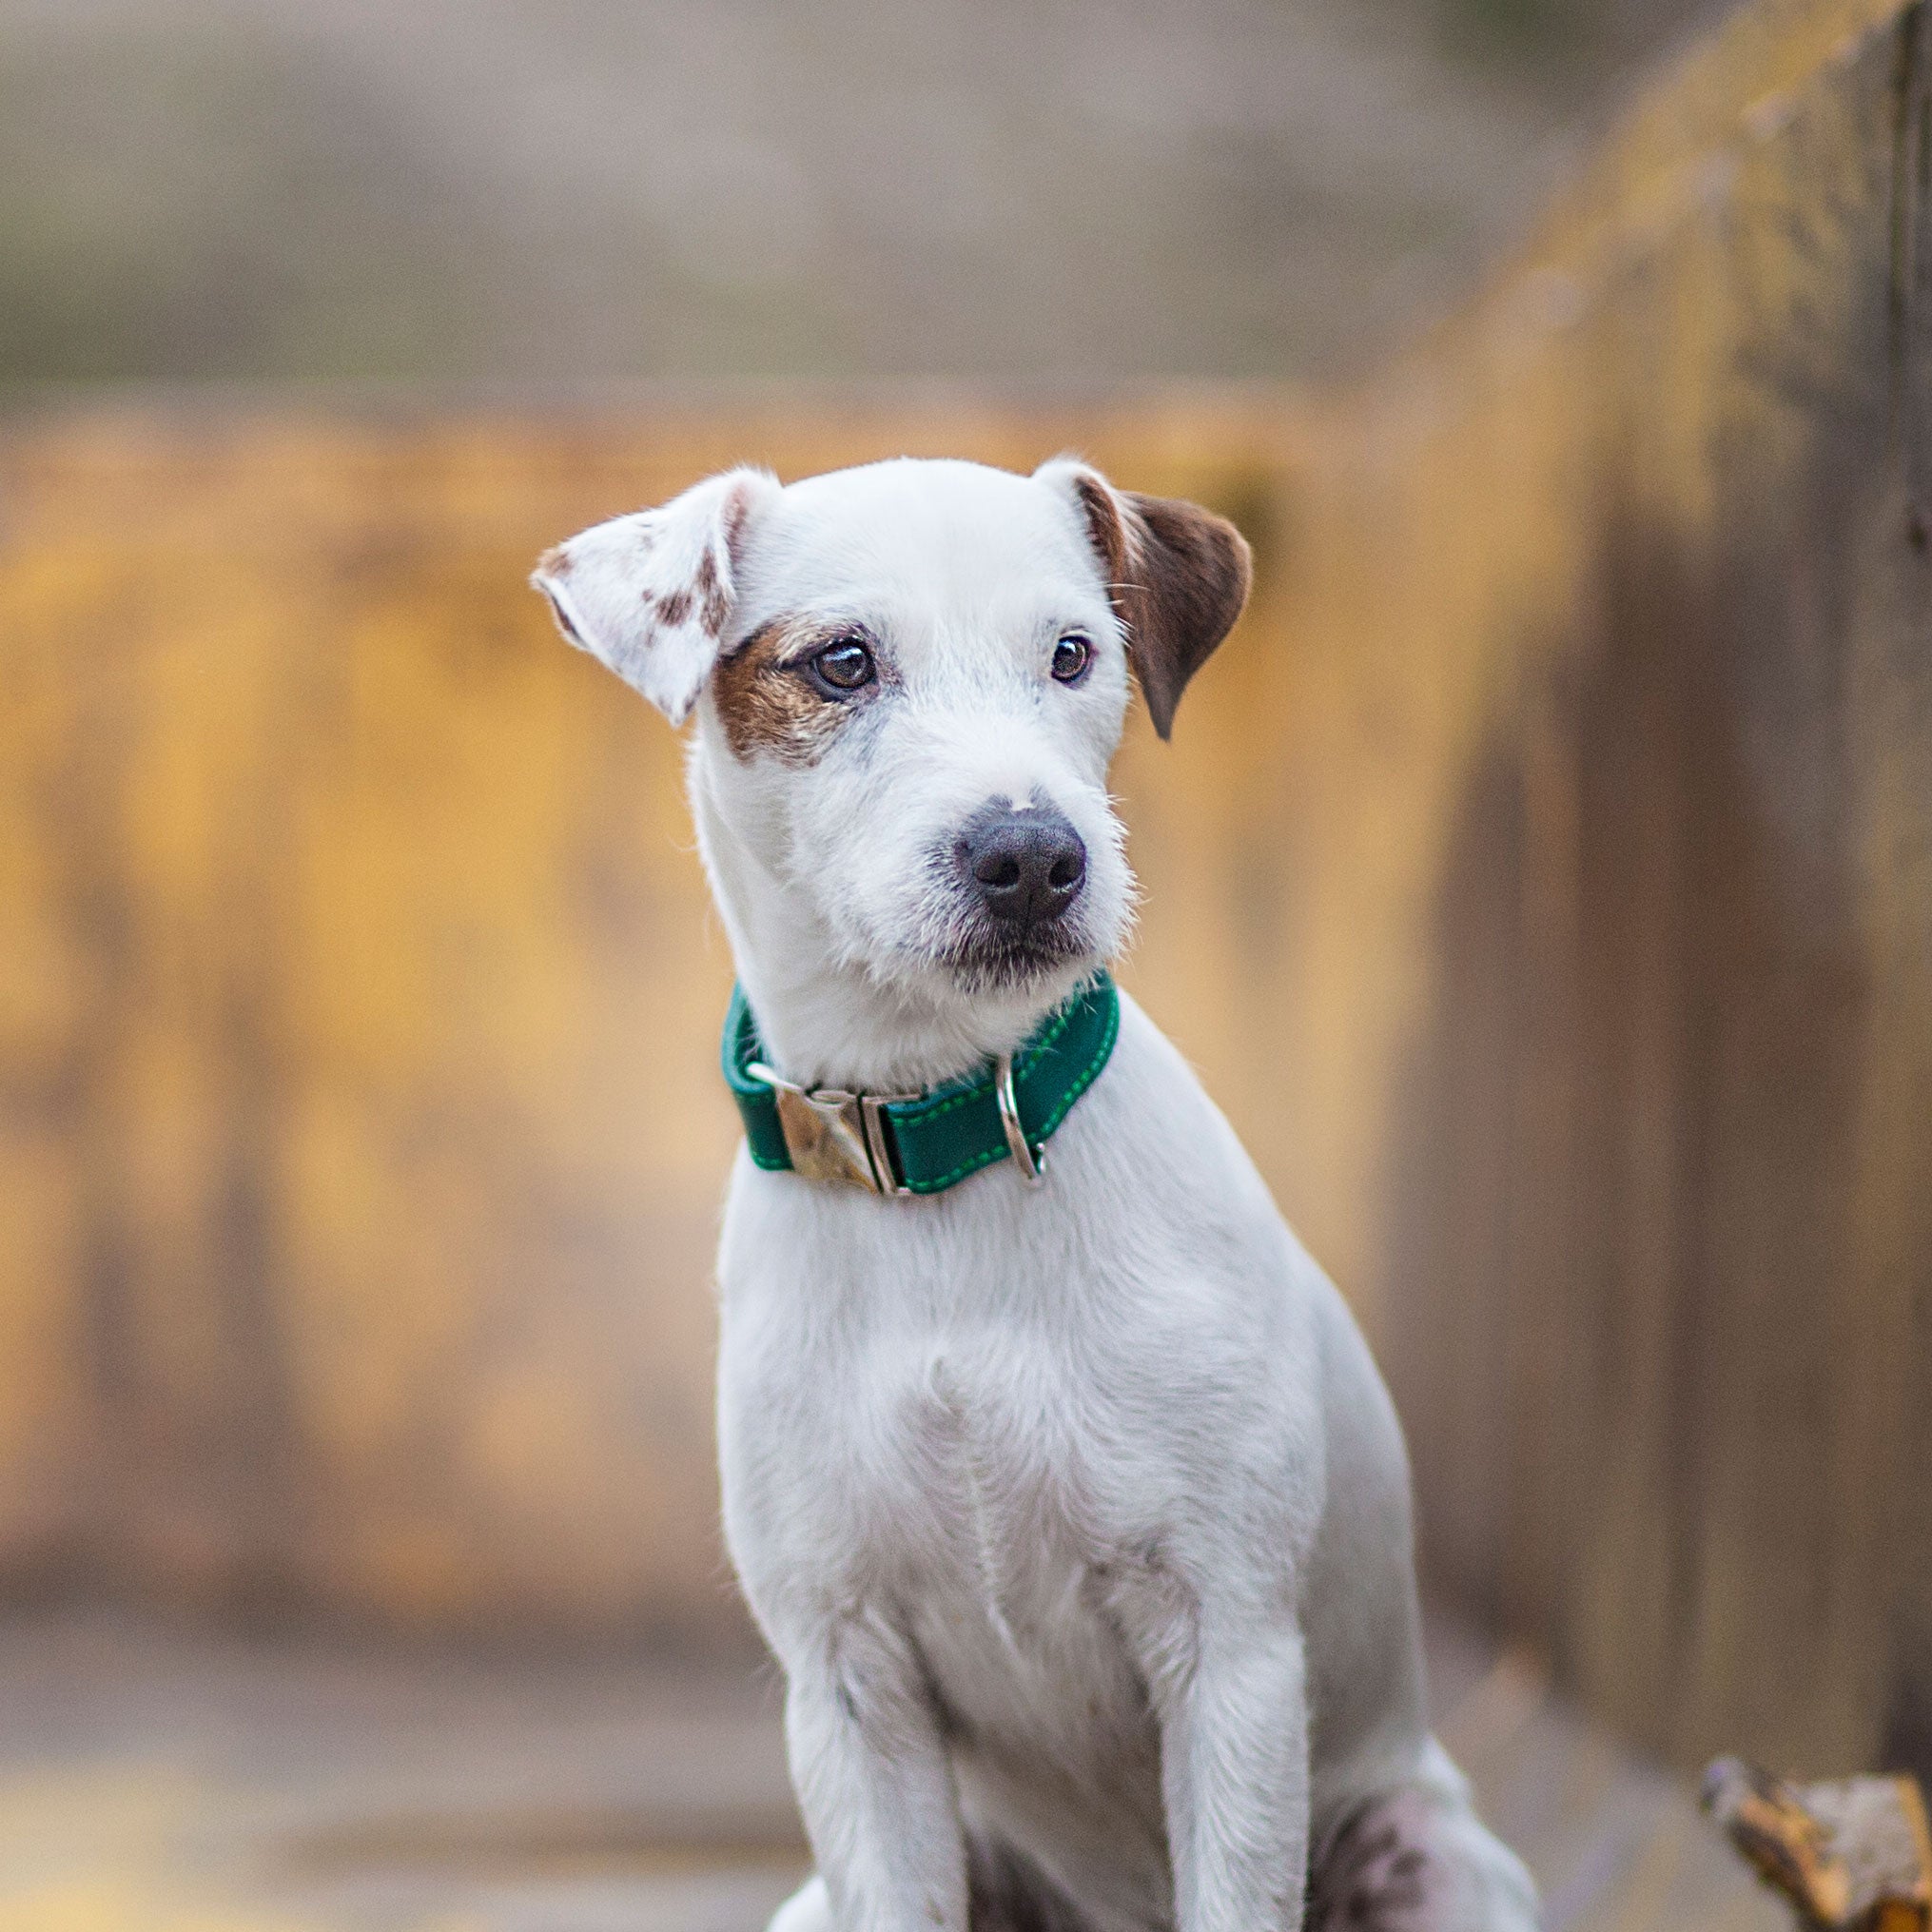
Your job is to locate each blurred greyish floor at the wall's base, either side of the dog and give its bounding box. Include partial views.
[0,1617,1786,1932]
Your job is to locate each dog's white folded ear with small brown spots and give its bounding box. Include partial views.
[529,470,778,725]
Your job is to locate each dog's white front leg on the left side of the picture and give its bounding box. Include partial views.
[785,1615,966,1932]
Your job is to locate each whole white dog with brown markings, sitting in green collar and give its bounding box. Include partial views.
[534,458,1536,1932]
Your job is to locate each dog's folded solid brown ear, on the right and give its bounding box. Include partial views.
[1034,456,1254,738]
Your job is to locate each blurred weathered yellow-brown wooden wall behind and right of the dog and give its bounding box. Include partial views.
[0,0,1932,1769]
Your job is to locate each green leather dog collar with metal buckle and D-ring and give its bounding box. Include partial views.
[723,972,1121,1194]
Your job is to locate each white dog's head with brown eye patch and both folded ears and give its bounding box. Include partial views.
[536,459,1248,1074]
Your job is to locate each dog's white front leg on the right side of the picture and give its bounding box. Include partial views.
[1156,1613,1308,1932]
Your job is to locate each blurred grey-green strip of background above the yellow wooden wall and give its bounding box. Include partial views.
[0,0,1727,392]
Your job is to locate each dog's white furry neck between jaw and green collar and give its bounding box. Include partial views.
[692,757,1082,1094]
